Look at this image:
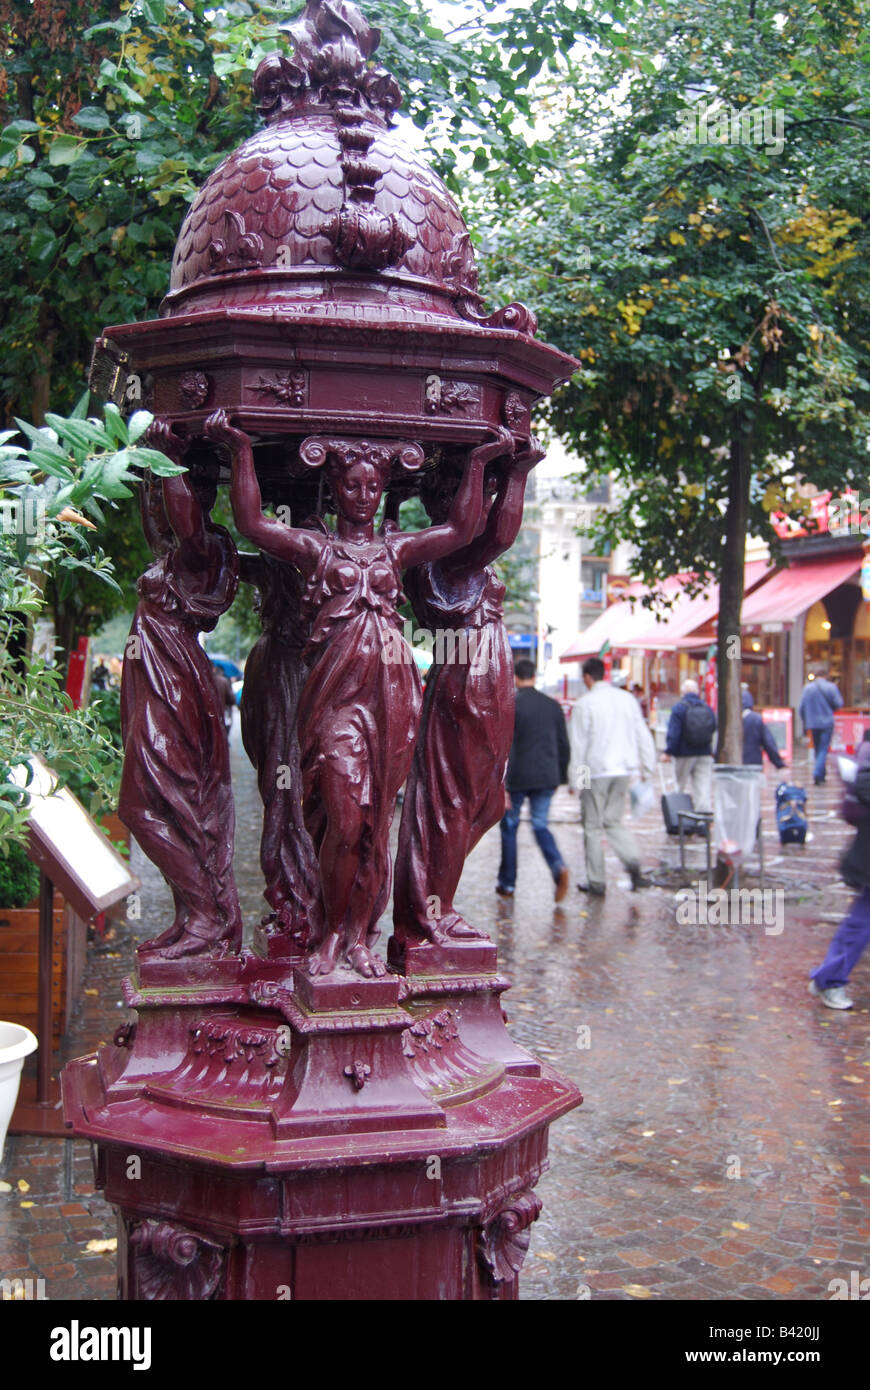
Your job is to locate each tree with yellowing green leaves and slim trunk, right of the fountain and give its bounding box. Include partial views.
[478,0,870,762]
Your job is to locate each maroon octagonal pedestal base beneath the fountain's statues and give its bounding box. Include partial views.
[64,942,581,1300]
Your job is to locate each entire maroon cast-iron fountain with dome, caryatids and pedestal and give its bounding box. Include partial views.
[64,0,581,1300]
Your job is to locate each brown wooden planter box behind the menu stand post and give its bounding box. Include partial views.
[0,894,88,1038]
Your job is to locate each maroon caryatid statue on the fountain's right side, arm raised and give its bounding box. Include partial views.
[393,438,543,944]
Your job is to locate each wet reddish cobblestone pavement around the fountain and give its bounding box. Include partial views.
[0,728,870,1301]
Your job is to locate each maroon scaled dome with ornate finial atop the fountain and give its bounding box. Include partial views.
[163,0,480,331]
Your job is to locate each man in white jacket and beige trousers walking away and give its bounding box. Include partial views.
[570,656,656,898]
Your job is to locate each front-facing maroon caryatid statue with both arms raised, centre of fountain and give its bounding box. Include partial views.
[206,411,513,977]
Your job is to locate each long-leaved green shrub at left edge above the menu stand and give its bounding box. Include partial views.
[0,396,183,853]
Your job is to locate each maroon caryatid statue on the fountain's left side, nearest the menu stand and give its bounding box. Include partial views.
[118,423,242,960]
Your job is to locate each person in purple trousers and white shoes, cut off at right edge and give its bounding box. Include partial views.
[810,728,870,1009]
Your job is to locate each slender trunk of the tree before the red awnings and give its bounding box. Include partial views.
[716,411,752,766]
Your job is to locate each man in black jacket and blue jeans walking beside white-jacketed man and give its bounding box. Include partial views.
[496,660,571,902]
